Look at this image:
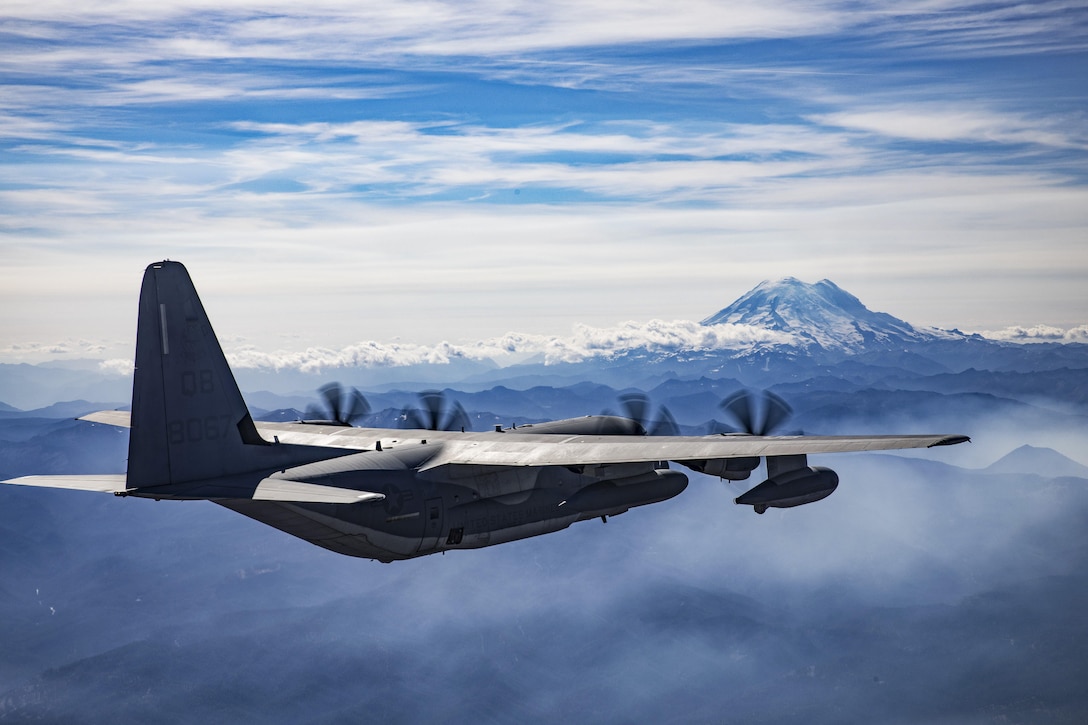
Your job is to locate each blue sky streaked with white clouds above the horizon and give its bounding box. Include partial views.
[0,0,1088,361]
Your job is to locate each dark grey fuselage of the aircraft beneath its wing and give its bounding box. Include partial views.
[217,435,688,562]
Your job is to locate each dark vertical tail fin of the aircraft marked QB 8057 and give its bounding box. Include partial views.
[127,261,338,489]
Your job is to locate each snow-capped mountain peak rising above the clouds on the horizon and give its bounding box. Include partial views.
[702,277,962,353]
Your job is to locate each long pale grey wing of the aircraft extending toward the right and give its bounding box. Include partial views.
[415,433,969,469]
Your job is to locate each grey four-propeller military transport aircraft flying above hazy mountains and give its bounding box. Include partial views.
[4,261,968,562]
